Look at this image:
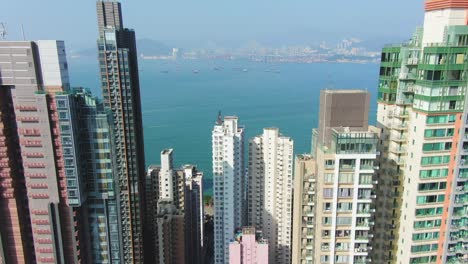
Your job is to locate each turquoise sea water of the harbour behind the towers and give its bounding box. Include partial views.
[70,59,378,193]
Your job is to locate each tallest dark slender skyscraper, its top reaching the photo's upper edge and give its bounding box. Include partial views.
[97,1,145,263]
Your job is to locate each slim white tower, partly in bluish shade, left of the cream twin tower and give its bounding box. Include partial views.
[212,116,245,264]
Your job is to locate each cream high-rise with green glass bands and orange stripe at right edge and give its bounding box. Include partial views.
[373,0,468,263]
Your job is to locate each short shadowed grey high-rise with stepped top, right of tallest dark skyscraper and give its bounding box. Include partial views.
[145,149,204,264]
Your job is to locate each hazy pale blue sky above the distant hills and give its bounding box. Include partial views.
[0,0,423,49]
